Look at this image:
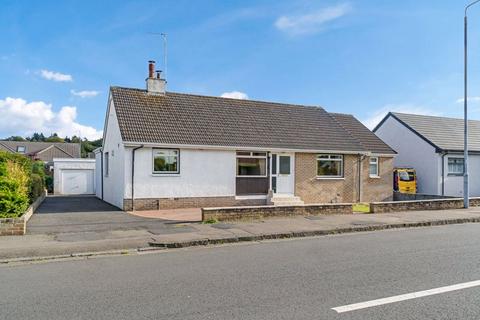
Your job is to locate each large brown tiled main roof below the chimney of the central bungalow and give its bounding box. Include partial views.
[111,87,396,152]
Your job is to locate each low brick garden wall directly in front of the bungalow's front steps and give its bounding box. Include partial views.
[202,203,352,221]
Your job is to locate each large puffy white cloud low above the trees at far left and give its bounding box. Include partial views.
[0,97,102,140]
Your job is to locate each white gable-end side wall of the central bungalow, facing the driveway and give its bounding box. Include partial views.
[103,102,125,209]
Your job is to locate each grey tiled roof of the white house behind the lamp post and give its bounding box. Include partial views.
[389,112,480,151]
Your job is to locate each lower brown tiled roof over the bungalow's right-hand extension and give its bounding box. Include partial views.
[330,113,396,154]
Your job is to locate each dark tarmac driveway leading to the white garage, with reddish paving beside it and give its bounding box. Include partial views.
[27,196,196,241]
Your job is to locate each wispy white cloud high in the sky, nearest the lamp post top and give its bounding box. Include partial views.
[275,3,352,35]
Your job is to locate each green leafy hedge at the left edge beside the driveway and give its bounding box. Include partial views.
[0,151,45,218]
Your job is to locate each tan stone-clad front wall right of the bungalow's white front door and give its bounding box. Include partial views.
[295,153,393,203]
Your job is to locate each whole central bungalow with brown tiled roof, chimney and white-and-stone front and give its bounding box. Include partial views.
[95,63,395,210]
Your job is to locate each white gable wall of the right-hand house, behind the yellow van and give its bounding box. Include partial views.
[375,116,442,195]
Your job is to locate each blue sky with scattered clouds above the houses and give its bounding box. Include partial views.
[0,0,480,138]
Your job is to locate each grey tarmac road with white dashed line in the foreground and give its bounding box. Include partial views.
[0,224,480,320]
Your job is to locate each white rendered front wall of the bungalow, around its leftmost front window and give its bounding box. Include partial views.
[125,148,236,199]
